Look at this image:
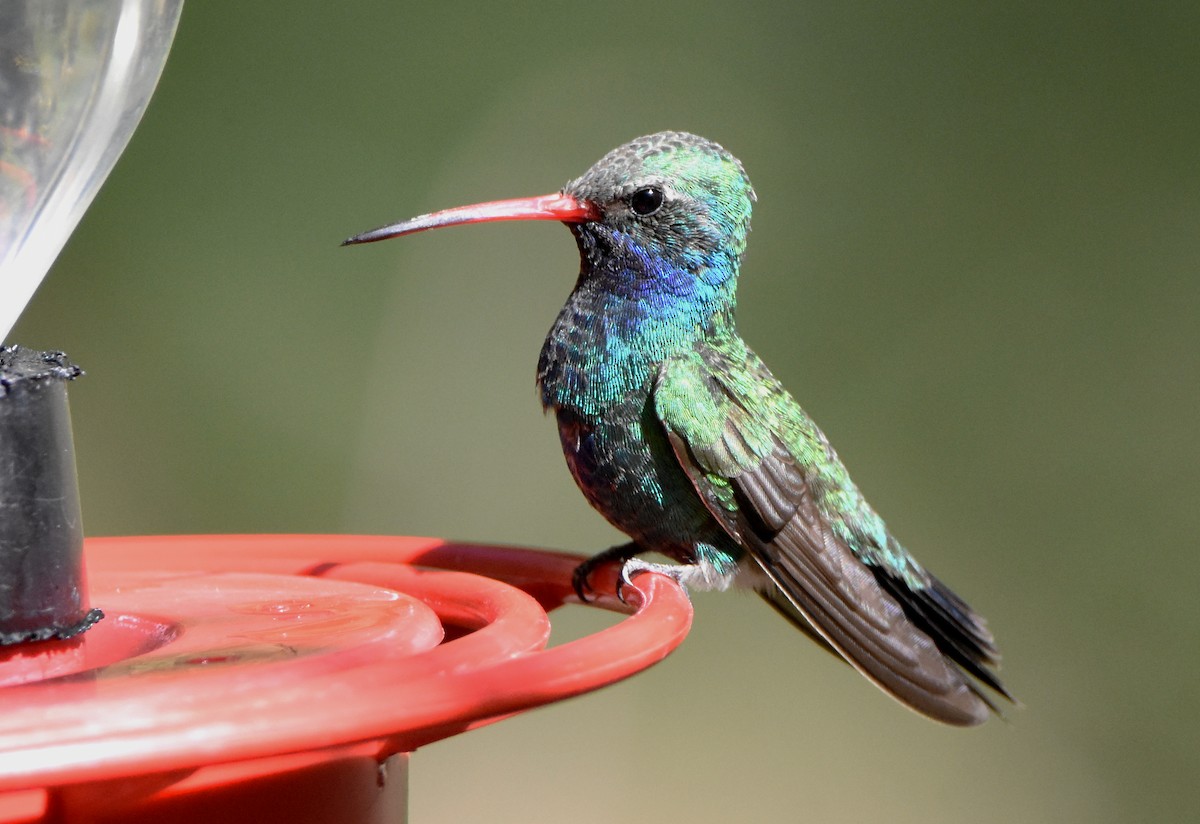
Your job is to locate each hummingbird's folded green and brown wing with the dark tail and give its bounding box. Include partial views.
[654,337,1008,724]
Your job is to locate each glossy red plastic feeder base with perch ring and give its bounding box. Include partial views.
[0,535,691,824]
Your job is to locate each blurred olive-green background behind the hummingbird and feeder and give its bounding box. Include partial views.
[11,0,1200,824]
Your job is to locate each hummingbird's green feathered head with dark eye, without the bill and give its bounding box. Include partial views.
[563,132,755,290]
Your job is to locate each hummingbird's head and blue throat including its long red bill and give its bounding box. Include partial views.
[343,132,755,318]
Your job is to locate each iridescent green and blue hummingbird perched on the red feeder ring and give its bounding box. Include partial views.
[343,132,1013,726]
